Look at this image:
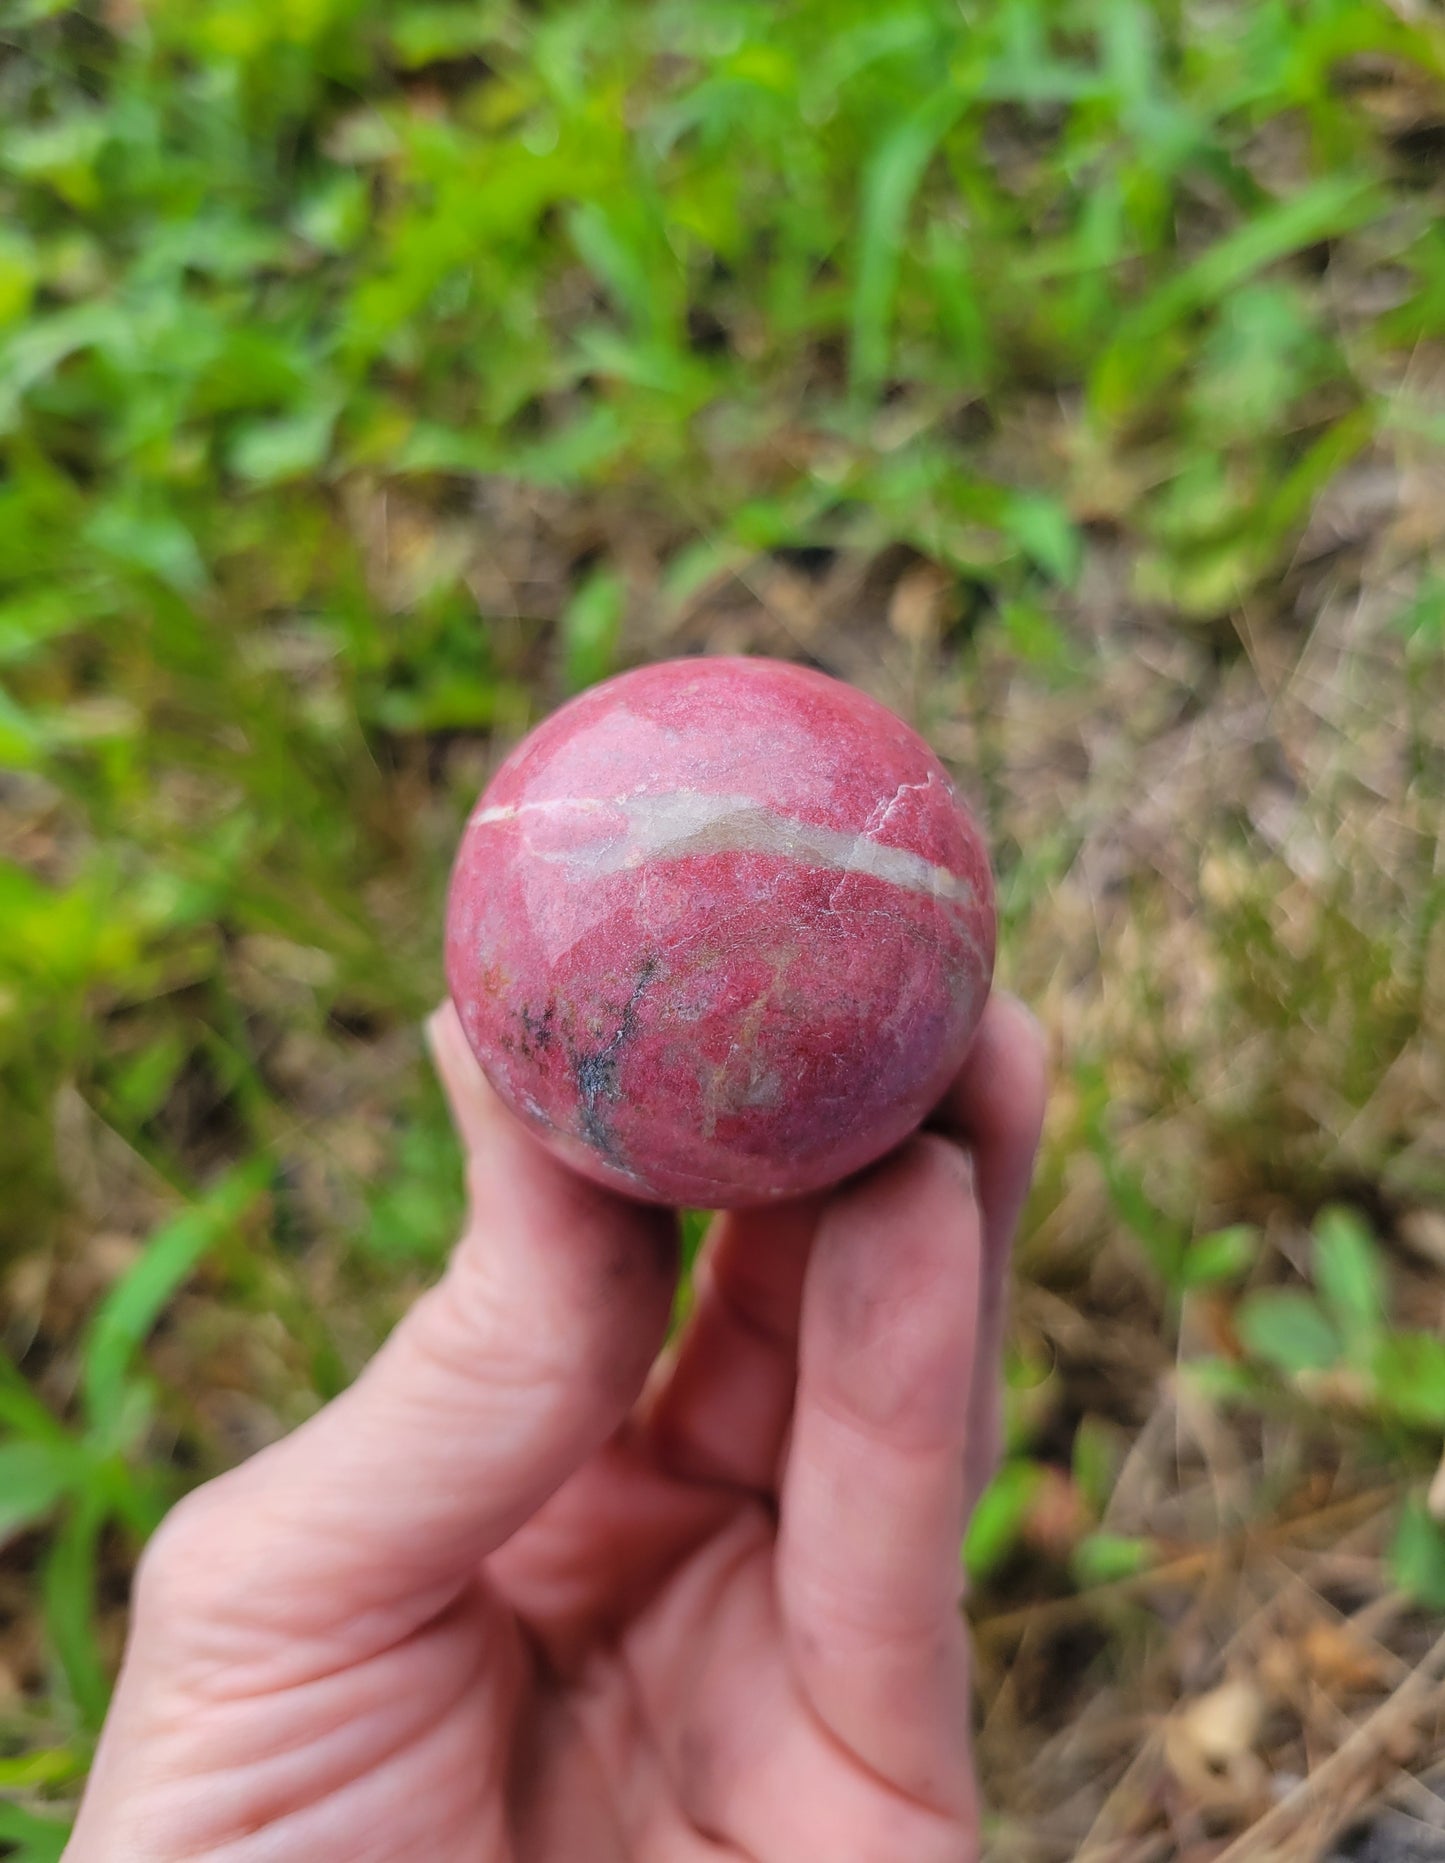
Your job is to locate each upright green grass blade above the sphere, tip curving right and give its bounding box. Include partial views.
[851,86,966,395]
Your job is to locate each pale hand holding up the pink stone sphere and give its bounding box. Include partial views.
[65,995,1045,1863]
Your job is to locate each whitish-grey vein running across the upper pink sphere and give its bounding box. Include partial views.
[469,784,974,907]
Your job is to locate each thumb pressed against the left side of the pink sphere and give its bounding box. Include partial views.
[149,1006,674,1654]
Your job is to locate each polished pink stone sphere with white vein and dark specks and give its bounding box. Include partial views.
[447,658,994,1209]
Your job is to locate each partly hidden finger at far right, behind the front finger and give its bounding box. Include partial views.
[931,991,1048,1513]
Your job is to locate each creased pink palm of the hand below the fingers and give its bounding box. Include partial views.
[283,1457,974,1863]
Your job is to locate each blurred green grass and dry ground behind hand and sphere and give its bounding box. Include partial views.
[0,0,1445,1863]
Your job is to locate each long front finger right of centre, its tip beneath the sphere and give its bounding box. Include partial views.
[778,1136,979,1811]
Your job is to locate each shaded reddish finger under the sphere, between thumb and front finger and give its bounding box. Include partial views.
[648,1198,821,1494]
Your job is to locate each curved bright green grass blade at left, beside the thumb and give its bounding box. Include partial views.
[82,1161,270,1440]
